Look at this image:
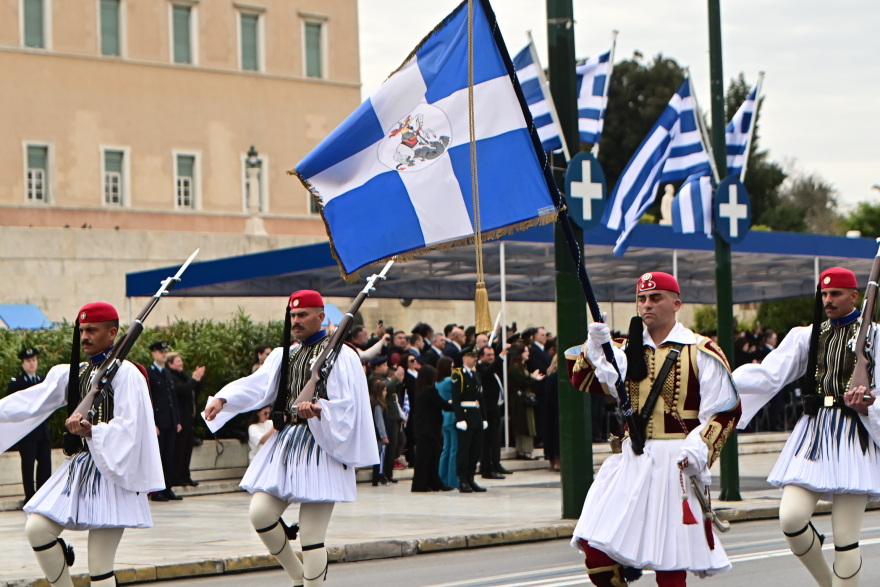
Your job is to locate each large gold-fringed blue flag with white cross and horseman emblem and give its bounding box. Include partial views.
[291,0,556,276]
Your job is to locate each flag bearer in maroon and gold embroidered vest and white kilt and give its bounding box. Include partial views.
[566,272,740,587]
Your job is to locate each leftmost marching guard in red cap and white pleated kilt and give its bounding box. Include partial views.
[0,302,165,587]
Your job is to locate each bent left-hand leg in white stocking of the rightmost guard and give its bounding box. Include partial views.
[779,485,832,587]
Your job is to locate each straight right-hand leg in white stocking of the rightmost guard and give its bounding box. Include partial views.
[831,494,868,587]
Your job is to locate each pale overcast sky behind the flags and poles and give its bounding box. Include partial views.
[358,0,880,211]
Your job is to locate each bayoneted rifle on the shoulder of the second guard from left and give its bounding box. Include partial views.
[272,259,394,430]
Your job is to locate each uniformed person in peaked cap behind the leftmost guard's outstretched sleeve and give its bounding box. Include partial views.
[7,347,52,501]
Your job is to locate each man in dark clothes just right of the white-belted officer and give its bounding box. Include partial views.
[477,346,510,479]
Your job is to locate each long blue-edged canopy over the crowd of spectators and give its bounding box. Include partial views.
[126,224,877,304]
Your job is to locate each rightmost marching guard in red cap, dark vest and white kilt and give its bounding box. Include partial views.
[733,268,880,587]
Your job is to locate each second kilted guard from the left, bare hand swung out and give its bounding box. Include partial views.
[204,290,379,586]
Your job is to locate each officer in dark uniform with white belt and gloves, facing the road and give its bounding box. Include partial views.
[452,346,488,493]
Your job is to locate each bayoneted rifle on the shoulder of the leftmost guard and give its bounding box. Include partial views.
[63,249,199,456]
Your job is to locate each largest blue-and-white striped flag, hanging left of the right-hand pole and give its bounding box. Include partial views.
[602,79,711,257]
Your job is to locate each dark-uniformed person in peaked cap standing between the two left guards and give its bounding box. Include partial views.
[147,340,182,501]
